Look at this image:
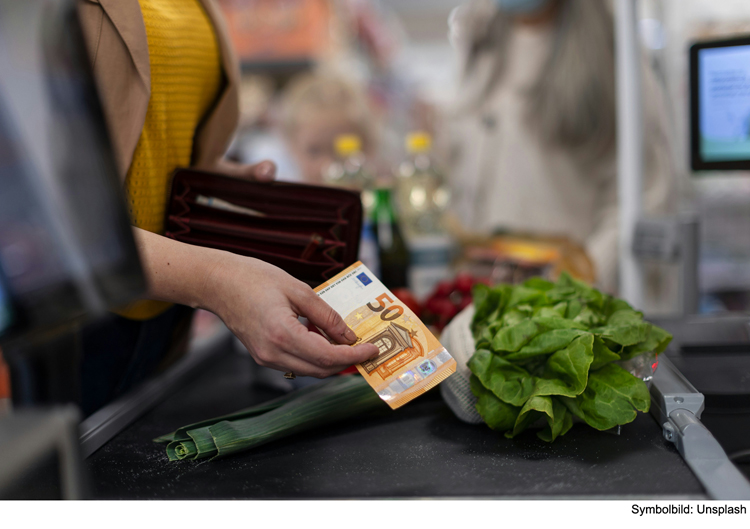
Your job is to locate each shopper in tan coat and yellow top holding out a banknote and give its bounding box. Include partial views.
[78,0,377,414]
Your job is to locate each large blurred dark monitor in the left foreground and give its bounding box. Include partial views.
[0,0,144,339]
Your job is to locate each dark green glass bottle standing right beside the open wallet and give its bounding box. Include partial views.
[372,187,409,289]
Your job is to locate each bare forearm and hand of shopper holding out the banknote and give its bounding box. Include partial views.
[133,228,378,378]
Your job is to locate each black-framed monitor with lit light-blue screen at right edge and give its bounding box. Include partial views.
[690,37,750,171]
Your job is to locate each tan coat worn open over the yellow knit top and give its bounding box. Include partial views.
[78,0,240,181]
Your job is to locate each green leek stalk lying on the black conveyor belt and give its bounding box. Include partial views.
[154,375,386,461]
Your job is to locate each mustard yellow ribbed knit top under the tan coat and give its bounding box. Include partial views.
[118,0,222,320]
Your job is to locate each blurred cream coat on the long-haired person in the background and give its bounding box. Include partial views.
[448,18,676,302]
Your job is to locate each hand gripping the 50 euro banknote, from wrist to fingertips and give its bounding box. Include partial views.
[205,253,378,378]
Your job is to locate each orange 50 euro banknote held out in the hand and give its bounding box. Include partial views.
[315,262,456,409]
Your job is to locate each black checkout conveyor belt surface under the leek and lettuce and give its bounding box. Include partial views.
[87,353,704,499]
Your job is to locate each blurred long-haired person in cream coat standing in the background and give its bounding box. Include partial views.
[449,0,675,292]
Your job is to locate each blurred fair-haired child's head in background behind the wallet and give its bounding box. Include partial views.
[281,72,376,184]
